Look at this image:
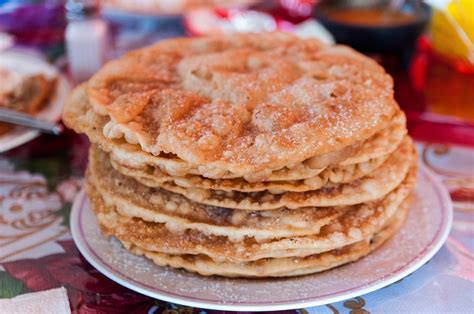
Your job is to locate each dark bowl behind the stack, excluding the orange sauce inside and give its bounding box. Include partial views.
[314,0,431,54]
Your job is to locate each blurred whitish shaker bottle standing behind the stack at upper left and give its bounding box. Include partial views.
[65,0,109,83]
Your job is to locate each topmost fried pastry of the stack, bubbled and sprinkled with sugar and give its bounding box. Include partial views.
[88,33,398,175]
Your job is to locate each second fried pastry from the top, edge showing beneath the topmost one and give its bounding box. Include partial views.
[63,85,406,182]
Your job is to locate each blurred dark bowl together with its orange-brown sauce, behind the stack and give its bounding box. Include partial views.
[314,0,430,60]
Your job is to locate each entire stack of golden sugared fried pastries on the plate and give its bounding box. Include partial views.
[63,33,416,277]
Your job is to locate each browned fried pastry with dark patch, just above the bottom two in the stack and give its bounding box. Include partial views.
[87,147,414,242]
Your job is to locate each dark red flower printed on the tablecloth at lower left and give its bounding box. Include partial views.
[2,240,158,313]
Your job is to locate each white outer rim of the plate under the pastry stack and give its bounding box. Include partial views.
[70,163,453,312]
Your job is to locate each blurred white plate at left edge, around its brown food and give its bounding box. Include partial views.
[0,50,70,153]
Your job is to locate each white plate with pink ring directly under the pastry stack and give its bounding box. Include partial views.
[71,165,452,311]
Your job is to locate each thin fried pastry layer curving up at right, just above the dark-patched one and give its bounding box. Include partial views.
[145,137,416,210]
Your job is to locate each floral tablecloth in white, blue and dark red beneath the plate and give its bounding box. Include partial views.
[0,128,474,314]
